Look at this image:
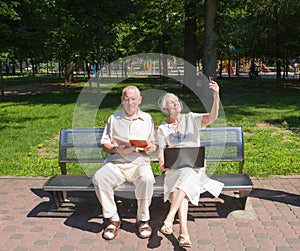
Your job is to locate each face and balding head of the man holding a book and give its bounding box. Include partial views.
[121,89,142,116]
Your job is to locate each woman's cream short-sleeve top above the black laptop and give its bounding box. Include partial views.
[158,112,204,148]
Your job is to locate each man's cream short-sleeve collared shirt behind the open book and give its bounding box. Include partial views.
[101,110,157,163]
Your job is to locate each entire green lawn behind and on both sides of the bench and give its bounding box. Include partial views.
[0,77,300,177]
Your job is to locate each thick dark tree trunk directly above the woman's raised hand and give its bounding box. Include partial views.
[203,0,217,78]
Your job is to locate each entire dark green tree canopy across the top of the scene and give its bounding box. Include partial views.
[0,0,300,82]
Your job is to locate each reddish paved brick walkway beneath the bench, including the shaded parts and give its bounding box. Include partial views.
[0,176,300,251]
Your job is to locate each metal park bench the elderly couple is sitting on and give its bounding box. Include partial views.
[43,127,253,210]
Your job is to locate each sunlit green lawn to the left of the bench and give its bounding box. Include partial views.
[0,86,78,176]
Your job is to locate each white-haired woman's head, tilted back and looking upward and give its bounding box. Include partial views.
[158,93,182,117]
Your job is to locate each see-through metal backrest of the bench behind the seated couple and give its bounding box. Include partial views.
[58,127,244,174]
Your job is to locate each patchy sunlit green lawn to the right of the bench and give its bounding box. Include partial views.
[218,80,300,177]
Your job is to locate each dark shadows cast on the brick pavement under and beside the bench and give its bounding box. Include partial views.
[27,188,300,250]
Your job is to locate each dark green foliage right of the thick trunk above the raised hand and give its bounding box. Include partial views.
[217,0,300,64]
